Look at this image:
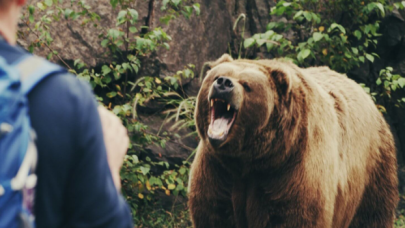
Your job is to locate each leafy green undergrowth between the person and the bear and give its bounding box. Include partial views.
[18,0,200,227]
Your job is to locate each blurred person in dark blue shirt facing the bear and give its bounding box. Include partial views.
[0,0,133,228]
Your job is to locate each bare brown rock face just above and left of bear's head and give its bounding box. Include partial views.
[154,0,232,83]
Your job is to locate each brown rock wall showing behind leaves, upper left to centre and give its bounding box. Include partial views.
[18,0,275,80]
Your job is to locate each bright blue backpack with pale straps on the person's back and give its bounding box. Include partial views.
[0,55,66,228]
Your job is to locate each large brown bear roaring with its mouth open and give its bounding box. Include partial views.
[189,55,398,228]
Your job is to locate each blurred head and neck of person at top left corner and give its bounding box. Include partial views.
[0,0,26,44]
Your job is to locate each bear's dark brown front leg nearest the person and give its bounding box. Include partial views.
[188,150,236,228]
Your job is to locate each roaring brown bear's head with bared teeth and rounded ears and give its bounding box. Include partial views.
[195,54,294,158]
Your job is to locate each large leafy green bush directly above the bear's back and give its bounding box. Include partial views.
[240,0,386,73]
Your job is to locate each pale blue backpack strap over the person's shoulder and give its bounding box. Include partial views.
[15,56,67,94]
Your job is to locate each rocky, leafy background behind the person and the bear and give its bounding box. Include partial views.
[18,0,405,228]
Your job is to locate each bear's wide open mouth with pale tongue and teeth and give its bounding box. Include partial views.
[208,98,237,144]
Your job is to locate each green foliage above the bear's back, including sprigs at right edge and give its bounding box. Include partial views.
[235,0,405,112]
